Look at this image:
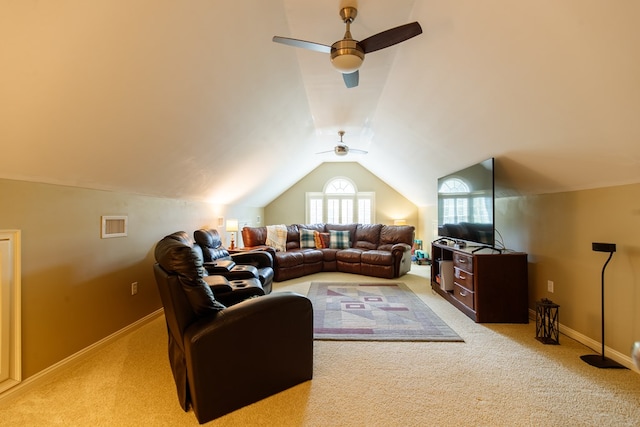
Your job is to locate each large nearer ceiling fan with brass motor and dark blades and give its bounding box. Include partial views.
[273,7,422,88]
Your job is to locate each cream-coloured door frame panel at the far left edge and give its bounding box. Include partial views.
[0,230,22,393]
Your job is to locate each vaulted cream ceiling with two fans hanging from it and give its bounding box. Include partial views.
[0,0,640,206]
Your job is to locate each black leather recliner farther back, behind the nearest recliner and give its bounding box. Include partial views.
[193,229,274,294]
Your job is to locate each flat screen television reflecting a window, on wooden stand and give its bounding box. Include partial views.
[438,158,495,247]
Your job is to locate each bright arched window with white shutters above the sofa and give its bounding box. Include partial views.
[306,177,375,224]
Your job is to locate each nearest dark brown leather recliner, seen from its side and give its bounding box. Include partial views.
[154,233,313,424]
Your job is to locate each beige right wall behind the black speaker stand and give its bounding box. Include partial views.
[496,184,640,356]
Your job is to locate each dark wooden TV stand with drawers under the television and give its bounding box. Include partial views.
[431,243,529,323]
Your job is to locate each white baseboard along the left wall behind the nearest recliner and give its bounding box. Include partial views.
[0,308,164,404]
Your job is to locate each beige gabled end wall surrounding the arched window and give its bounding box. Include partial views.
[264,162,421,238]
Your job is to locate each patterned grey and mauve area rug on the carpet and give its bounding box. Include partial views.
[307,282,463,341]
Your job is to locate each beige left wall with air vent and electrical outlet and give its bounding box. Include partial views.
[0,179,262,378]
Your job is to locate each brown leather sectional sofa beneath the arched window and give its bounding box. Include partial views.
[242,224,415,282]
